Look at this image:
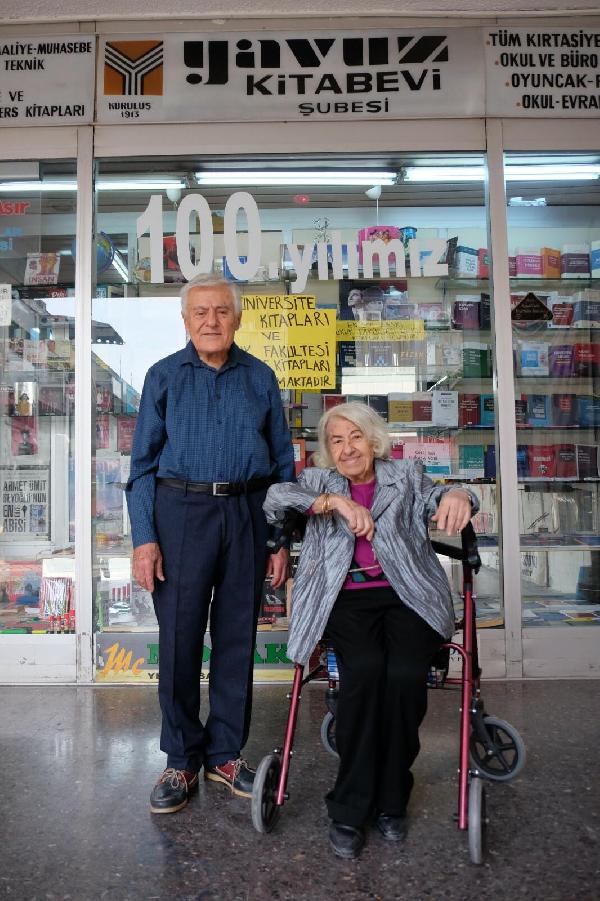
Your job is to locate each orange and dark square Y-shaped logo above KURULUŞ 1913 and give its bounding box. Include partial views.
[104,41,164,96]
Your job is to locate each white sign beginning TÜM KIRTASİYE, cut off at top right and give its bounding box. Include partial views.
[485,28,600,118]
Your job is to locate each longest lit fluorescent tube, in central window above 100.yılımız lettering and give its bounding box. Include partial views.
[195,169,397,187]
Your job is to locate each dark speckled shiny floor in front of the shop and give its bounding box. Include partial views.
[0,681,600,901]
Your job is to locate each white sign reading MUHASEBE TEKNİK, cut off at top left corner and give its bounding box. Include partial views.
[0,34,95,126]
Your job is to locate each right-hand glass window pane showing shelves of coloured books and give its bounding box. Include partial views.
[506,153,600,627]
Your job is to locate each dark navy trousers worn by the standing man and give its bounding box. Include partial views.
[153,485,267,772]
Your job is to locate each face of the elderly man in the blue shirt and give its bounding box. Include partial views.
[182,285,241,366]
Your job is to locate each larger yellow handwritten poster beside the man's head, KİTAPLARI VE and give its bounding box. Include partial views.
[236,294,336,391]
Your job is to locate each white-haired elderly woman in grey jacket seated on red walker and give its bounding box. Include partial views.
[264,403,477,859]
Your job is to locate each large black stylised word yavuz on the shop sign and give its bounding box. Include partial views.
[183,34,448,94]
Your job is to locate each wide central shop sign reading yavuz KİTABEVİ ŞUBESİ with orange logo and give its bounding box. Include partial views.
[97,27,484,123]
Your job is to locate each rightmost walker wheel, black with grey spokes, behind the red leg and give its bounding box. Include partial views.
[469,715,526,782]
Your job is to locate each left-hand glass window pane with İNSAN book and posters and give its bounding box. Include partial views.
[0,161,76,634]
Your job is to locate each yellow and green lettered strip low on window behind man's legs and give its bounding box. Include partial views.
[96,631,292,682]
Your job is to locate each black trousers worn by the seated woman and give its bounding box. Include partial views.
[326,588,443,826]
